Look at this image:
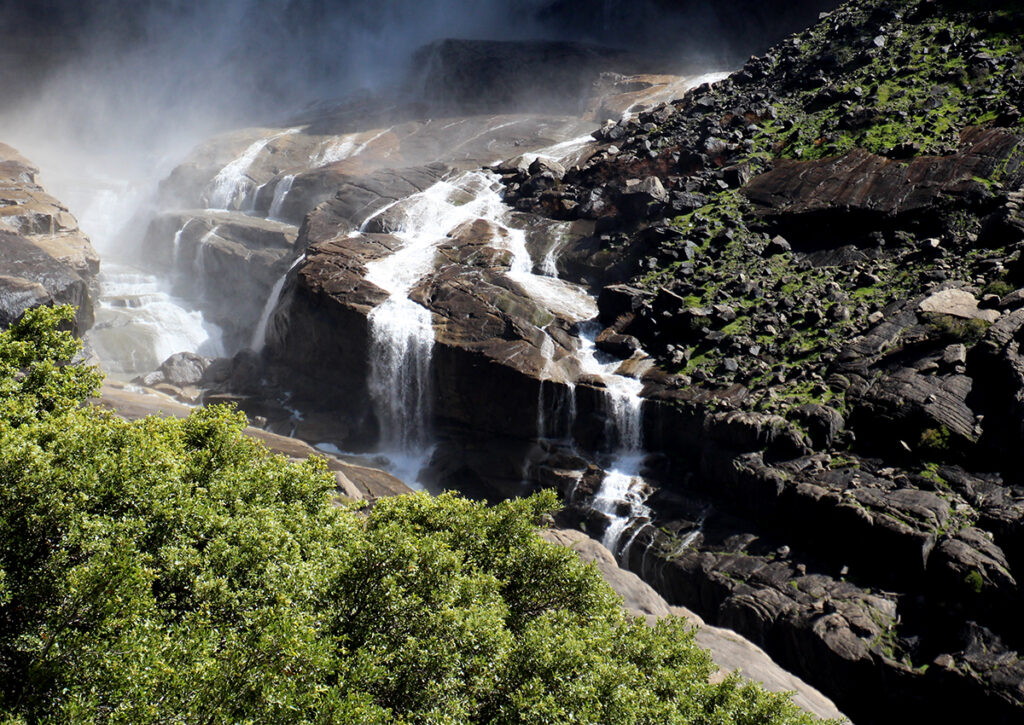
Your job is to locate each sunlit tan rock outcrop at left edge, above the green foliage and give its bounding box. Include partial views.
[0,143,99,335]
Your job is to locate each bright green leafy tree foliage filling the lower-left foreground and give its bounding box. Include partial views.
[0,308,831,725]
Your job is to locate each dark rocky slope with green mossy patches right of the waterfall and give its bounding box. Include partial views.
[505,1,1024,722]
